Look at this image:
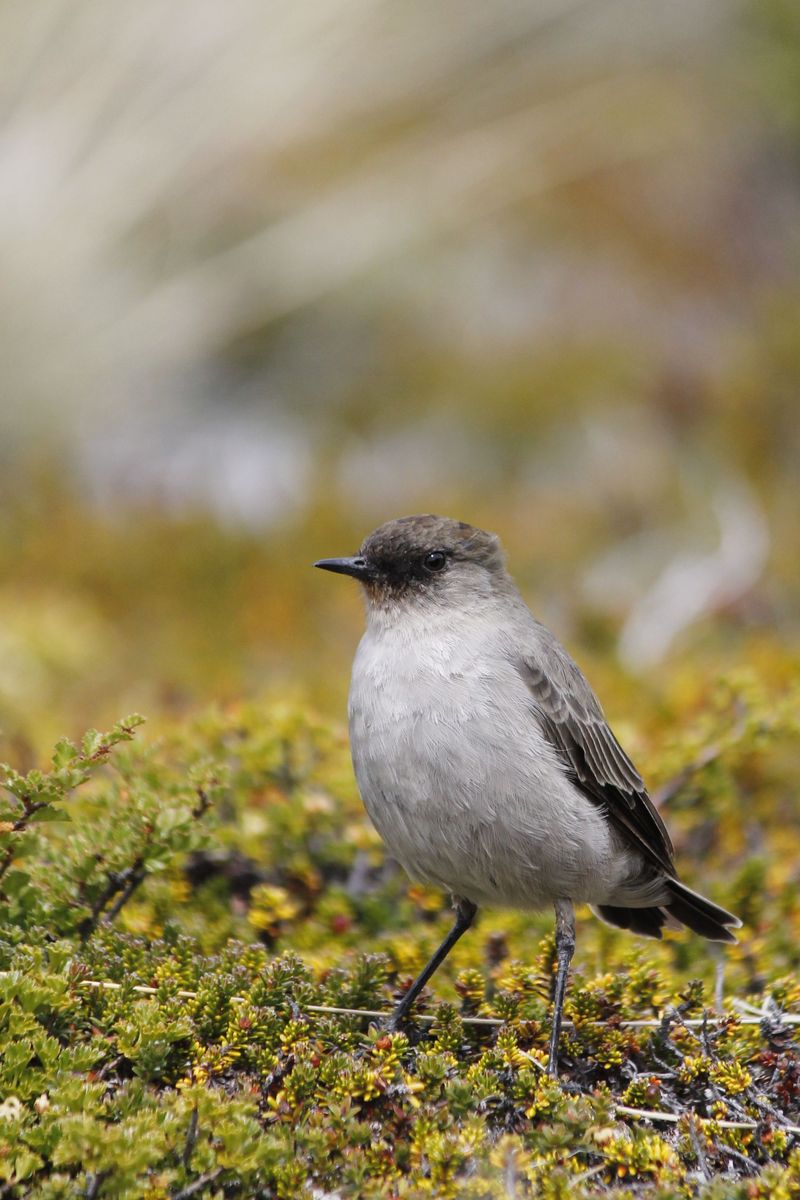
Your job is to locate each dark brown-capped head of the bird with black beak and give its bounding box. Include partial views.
[314,514,505,608]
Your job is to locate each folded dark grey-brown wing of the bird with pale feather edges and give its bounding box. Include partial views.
[519,624,675,875]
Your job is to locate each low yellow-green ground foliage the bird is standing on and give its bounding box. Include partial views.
[0,671,800,1200]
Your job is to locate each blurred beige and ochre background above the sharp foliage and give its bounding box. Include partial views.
[0,0,800,748]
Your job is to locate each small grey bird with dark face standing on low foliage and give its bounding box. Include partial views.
[314,514,741,1076]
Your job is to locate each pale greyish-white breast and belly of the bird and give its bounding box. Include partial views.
[350,611,631,908]
